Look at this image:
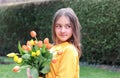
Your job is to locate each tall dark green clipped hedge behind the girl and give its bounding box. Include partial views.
[0,0,120,78]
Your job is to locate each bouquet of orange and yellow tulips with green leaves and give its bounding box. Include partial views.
[7,31,53,78]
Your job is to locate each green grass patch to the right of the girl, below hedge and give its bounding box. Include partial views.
[80,66,120,78]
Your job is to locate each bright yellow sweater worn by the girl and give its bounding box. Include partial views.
[46,42,79,78]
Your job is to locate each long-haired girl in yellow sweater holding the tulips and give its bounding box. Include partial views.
[27,8,81,78]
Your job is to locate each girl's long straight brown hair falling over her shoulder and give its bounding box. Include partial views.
[52,8,81,57]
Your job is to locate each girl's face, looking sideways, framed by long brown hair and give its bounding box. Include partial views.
[55,16,73,43]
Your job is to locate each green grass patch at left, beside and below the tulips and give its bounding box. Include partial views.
[0,57,27,78]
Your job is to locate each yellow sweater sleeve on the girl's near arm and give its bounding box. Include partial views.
[56,48,76,78]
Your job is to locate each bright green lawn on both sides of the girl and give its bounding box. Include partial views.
[0,59,120,78]
